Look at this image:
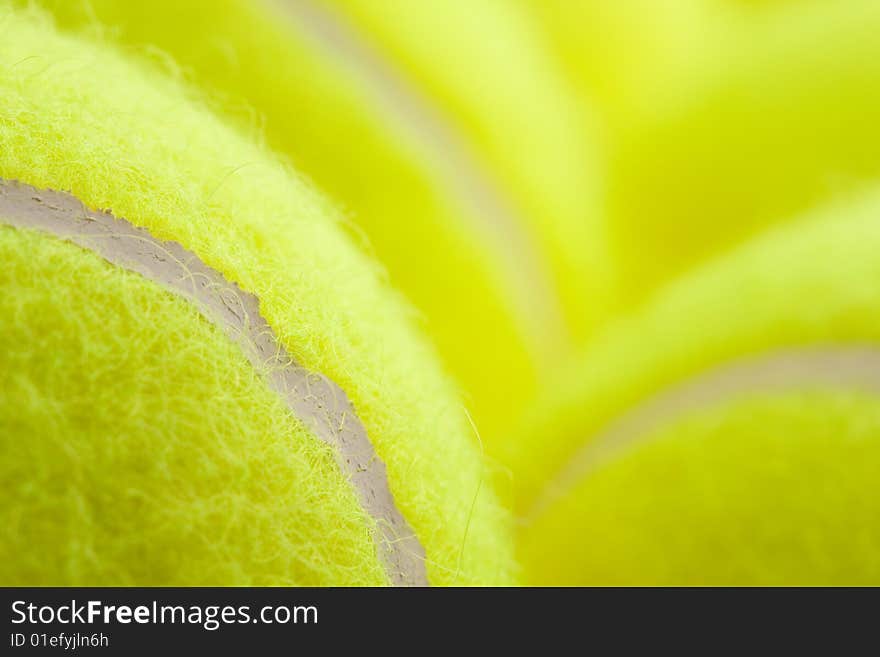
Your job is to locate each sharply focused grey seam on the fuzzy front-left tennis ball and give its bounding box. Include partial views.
[0,179,428,586]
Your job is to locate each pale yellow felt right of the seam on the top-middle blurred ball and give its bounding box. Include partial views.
[319,0,607,336]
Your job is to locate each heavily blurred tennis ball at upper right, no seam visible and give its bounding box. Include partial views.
[606,0,880,308]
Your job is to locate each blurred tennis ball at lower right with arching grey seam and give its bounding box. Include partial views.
[509,194,880,585]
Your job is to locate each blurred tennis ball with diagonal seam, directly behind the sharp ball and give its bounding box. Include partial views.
[29,0,606,451]
